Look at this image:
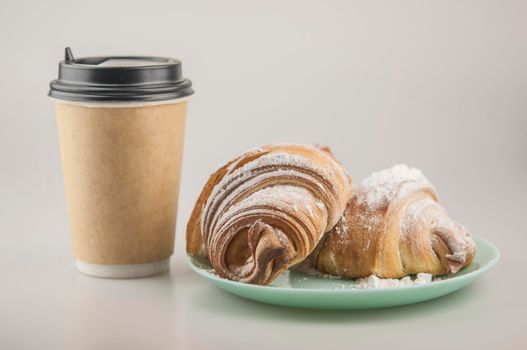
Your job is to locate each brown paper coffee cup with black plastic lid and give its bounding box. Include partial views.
[49,48,194,278]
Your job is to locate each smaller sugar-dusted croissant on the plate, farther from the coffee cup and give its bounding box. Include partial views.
[300,165,475,278]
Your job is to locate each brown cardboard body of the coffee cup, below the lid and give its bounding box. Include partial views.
[55,102,187,264]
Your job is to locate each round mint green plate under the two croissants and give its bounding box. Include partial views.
[189,237,499,309]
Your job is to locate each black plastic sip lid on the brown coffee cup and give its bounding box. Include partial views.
[49,47,194,101]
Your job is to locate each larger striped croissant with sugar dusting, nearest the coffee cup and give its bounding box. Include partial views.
[187,144,351,285]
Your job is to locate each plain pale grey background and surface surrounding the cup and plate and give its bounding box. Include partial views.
[0,0,527,349]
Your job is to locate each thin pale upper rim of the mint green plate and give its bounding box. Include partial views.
[187,235,501,294]
